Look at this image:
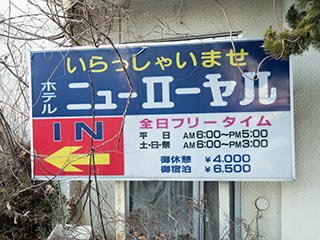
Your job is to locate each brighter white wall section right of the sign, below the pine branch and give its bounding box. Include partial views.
[281,46,320,240]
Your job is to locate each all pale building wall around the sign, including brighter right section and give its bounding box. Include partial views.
[72,0,320,240]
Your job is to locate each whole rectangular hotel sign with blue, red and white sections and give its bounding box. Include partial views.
[30,40,295,181]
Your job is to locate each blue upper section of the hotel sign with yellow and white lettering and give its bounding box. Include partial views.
[31,41,290,117]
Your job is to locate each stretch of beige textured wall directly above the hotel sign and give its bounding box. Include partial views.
[122,0,282,42]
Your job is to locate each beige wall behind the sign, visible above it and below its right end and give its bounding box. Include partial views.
[122,0,284,239]
